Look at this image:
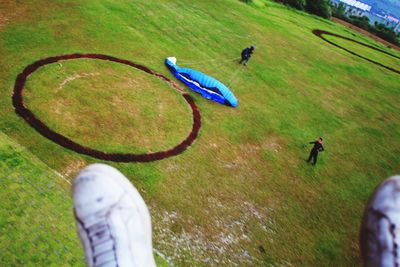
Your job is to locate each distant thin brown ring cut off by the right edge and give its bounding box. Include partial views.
[312,30,400,74]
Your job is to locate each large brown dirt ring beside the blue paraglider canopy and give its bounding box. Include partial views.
[12,54,201,162]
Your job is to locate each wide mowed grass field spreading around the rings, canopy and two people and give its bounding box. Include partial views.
[0,0,400,266]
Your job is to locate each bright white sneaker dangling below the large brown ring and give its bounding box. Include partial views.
[73,164,155,267]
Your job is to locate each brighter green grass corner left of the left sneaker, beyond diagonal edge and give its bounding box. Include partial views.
[0,133,83,266]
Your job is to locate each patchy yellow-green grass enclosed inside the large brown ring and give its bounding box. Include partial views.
[24,59,193,153]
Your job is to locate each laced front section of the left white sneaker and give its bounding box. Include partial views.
[85,218,118,267]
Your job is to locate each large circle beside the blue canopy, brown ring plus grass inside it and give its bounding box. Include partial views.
[12,54,201,162]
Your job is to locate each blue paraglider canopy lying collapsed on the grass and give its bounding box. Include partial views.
[165,57,238,107]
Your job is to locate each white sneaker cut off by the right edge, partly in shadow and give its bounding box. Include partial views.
[360,176,400,267]
